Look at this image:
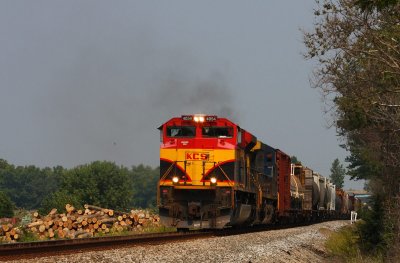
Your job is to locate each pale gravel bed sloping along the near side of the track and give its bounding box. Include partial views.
[8,221,349,263]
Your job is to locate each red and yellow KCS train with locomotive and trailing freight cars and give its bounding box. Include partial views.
[157,114,349,229]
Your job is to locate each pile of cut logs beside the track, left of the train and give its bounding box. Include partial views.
[0,204,160,242]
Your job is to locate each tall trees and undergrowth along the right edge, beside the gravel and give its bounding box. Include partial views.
[304,0,400,261]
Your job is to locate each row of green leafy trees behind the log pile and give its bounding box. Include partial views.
[0,159,159,217]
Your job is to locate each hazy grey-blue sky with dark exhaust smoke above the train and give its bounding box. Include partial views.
[0,0,363,188]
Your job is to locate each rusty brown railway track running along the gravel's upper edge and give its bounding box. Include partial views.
[0,220,332,261]
